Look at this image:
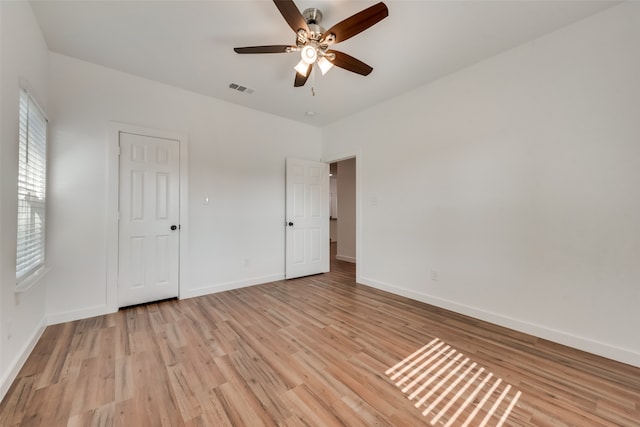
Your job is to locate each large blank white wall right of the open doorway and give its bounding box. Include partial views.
[323,2,640,366]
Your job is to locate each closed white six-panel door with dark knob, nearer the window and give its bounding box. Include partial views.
[118,133,180,307]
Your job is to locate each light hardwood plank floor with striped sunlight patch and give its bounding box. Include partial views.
[0,249,640,427]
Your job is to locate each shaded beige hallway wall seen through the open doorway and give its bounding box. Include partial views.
[336,158,356,262]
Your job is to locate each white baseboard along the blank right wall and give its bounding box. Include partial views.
[359,277,640,367]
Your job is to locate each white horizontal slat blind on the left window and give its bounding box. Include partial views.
[16,90,47,284]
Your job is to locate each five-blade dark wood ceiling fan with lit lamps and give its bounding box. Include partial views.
[233,0,389,87]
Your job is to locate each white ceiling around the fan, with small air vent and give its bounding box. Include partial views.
[31,0,618,126]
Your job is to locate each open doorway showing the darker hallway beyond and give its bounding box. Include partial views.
[329,157,356,264]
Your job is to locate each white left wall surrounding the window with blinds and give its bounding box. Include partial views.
[0,1,49,398]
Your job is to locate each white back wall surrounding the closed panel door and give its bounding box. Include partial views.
[47,54,321,322]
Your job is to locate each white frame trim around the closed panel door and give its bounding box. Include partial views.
[106,122,189,312]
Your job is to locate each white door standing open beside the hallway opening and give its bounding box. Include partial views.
[285,159,329,279]
